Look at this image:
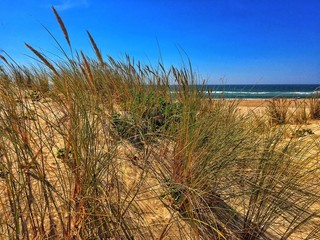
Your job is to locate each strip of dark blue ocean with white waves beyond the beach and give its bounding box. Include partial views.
[198,84,320,99]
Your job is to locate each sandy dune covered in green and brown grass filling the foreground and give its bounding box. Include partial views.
[0,8,320,239]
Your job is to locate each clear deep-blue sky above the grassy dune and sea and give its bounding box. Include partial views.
[0,0,320,84]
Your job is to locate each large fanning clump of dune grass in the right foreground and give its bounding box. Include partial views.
[154,95,319,239]
